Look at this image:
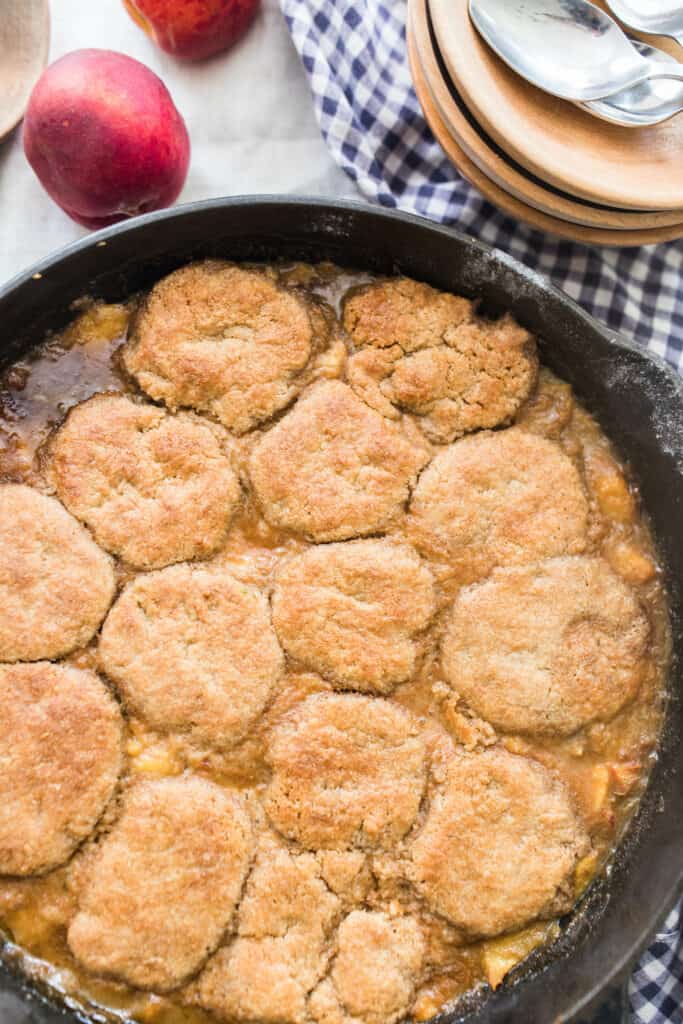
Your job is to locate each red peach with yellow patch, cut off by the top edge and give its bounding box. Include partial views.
[124,0,260,60]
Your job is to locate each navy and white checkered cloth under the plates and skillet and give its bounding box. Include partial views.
[281,0,683,1024]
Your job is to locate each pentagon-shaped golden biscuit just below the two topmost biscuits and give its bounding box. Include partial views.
[249,381,428,541]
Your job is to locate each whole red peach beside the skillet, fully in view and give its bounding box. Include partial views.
[24,49,189,228]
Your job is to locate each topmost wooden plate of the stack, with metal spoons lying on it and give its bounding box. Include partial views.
[429,0,683,213]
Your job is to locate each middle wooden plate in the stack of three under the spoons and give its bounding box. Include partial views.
[411,0,683,230]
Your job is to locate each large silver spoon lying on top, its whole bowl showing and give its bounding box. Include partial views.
[469,0,683,102]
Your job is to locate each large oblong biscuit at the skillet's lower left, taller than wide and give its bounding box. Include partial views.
[68,776,254,992]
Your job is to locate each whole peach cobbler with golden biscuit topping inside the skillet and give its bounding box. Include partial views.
[0,261,669,1024]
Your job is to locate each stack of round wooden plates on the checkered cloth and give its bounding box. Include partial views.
[408,0,683,246]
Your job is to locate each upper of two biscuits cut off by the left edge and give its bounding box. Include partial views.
[0,483,115,662]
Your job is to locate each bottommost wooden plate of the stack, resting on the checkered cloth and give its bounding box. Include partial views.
[408,8,683,247]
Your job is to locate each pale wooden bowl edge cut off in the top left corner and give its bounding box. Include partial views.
[0,0,50,139]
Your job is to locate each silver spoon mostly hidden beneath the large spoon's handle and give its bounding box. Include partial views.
[577,39,683,128]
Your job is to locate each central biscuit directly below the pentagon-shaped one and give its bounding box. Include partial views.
[272,540,436,693]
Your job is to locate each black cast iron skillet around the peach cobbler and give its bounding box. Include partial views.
[0,197,683,1024]
